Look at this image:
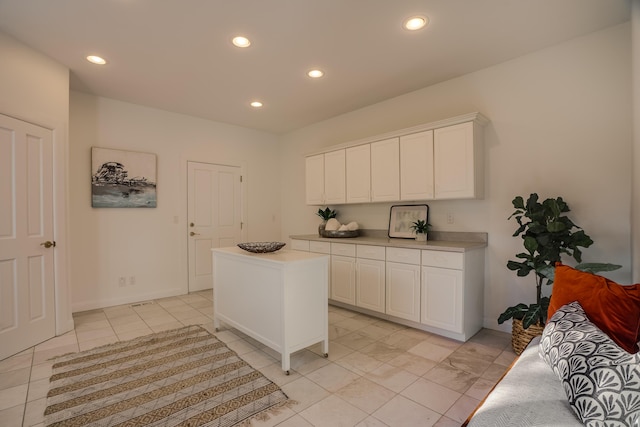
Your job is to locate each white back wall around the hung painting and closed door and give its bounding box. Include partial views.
[69,92,280,312]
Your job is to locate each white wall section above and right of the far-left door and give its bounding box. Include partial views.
[0,33,73,334]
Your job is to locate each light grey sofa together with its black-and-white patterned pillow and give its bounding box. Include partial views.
[468,301,640,427]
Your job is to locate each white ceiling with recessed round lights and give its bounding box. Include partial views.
[0,0,630,133]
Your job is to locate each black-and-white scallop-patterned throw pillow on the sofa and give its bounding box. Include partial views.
[538,301,640,427]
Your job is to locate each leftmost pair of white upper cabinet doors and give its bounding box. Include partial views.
[305,150,346,205]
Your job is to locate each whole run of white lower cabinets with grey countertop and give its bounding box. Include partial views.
[291,239,484,341]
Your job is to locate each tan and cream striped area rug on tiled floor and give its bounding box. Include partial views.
[45,326,290,427]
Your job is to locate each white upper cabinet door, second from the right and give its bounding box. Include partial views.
[400,130,434,200]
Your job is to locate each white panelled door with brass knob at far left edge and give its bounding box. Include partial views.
[0,114,56,359]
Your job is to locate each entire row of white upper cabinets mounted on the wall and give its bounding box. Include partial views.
[306,113,487,205]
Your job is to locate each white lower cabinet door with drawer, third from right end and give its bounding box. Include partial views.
[356,245,385,313]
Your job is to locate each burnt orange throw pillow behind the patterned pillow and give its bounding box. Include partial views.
[547,263,640,353]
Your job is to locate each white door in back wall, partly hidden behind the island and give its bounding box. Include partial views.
[187,162,242,292]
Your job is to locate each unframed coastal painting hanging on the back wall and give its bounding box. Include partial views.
[91,147,157,208]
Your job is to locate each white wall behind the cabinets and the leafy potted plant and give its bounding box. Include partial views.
[281,23,632,329]
